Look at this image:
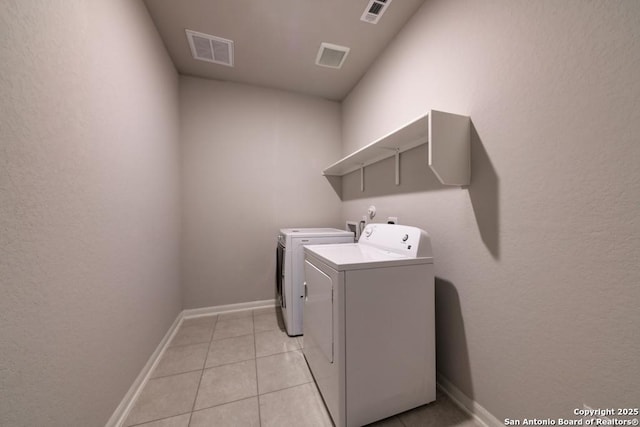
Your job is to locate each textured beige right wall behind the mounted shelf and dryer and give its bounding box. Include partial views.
[343,0,640,419]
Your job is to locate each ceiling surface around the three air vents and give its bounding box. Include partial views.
[145,0,424,100]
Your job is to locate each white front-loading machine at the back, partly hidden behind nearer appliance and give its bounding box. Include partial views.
[276,228,353,336]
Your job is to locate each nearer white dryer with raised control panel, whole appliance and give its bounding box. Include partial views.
[303,224,436,427]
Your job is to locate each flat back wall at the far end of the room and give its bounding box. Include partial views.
[180,77,344,308]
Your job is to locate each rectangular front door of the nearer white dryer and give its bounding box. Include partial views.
[304,260,333,364]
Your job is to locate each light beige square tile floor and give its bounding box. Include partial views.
[124,308,479,427]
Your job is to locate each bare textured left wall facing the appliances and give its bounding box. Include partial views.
[0,0,181,426]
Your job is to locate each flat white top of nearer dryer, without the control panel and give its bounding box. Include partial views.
[304,243,433,271]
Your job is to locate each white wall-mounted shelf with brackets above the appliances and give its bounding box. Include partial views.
[322,110,471,191]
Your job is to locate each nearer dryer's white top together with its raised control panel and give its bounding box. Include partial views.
[305,224,433,270]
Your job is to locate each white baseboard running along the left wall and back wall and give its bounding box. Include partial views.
[105,299,275,427]
